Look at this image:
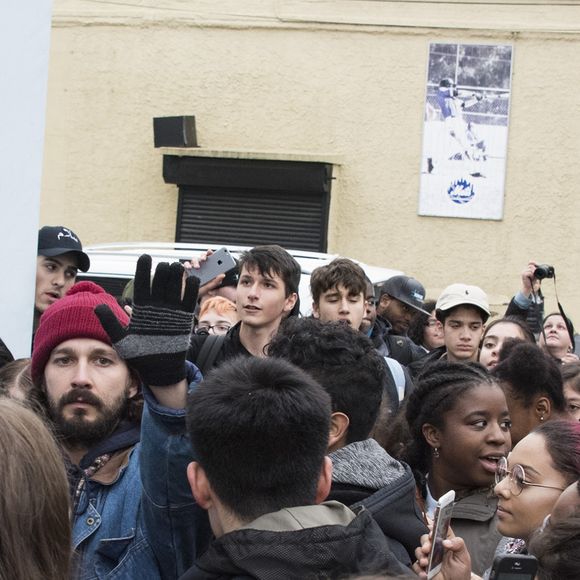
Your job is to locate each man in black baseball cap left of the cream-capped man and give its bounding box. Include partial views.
[371,276,428,365]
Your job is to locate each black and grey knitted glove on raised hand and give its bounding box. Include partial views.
[95,254,199,387]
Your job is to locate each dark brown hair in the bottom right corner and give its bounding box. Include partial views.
[529,509,580,580]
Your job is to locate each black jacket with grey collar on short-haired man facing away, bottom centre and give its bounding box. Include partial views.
[181,502,414,580]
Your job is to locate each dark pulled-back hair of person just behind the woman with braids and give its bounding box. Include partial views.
[492,341,566,412]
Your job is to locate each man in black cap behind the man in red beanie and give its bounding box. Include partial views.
[34,226,91,330]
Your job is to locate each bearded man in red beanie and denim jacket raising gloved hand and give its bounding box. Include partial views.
[31,256,210,579]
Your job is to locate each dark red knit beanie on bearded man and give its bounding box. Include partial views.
[30,282,129,385]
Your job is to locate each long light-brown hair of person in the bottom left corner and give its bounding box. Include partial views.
[0,397,72,580]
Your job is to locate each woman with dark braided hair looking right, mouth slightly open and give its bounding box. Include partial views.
[403,362,511,574]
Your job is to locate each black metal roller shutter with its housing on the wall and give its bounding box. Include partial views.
[164,156,332,252]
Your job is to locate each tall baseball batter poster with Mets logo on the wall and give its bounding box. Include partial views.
[418,43,513,220]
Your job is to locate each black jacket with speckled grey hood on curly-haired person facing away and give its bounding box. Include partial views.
[328,439,428,565]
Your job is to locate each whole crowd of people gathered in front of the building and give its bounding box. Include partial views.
[0,226,580,580]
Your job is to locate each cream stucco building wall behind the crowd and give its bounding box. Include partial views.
[41,0,580,326]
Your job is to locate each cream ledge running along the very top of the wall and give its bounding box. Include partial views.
[53,0,580,33]
